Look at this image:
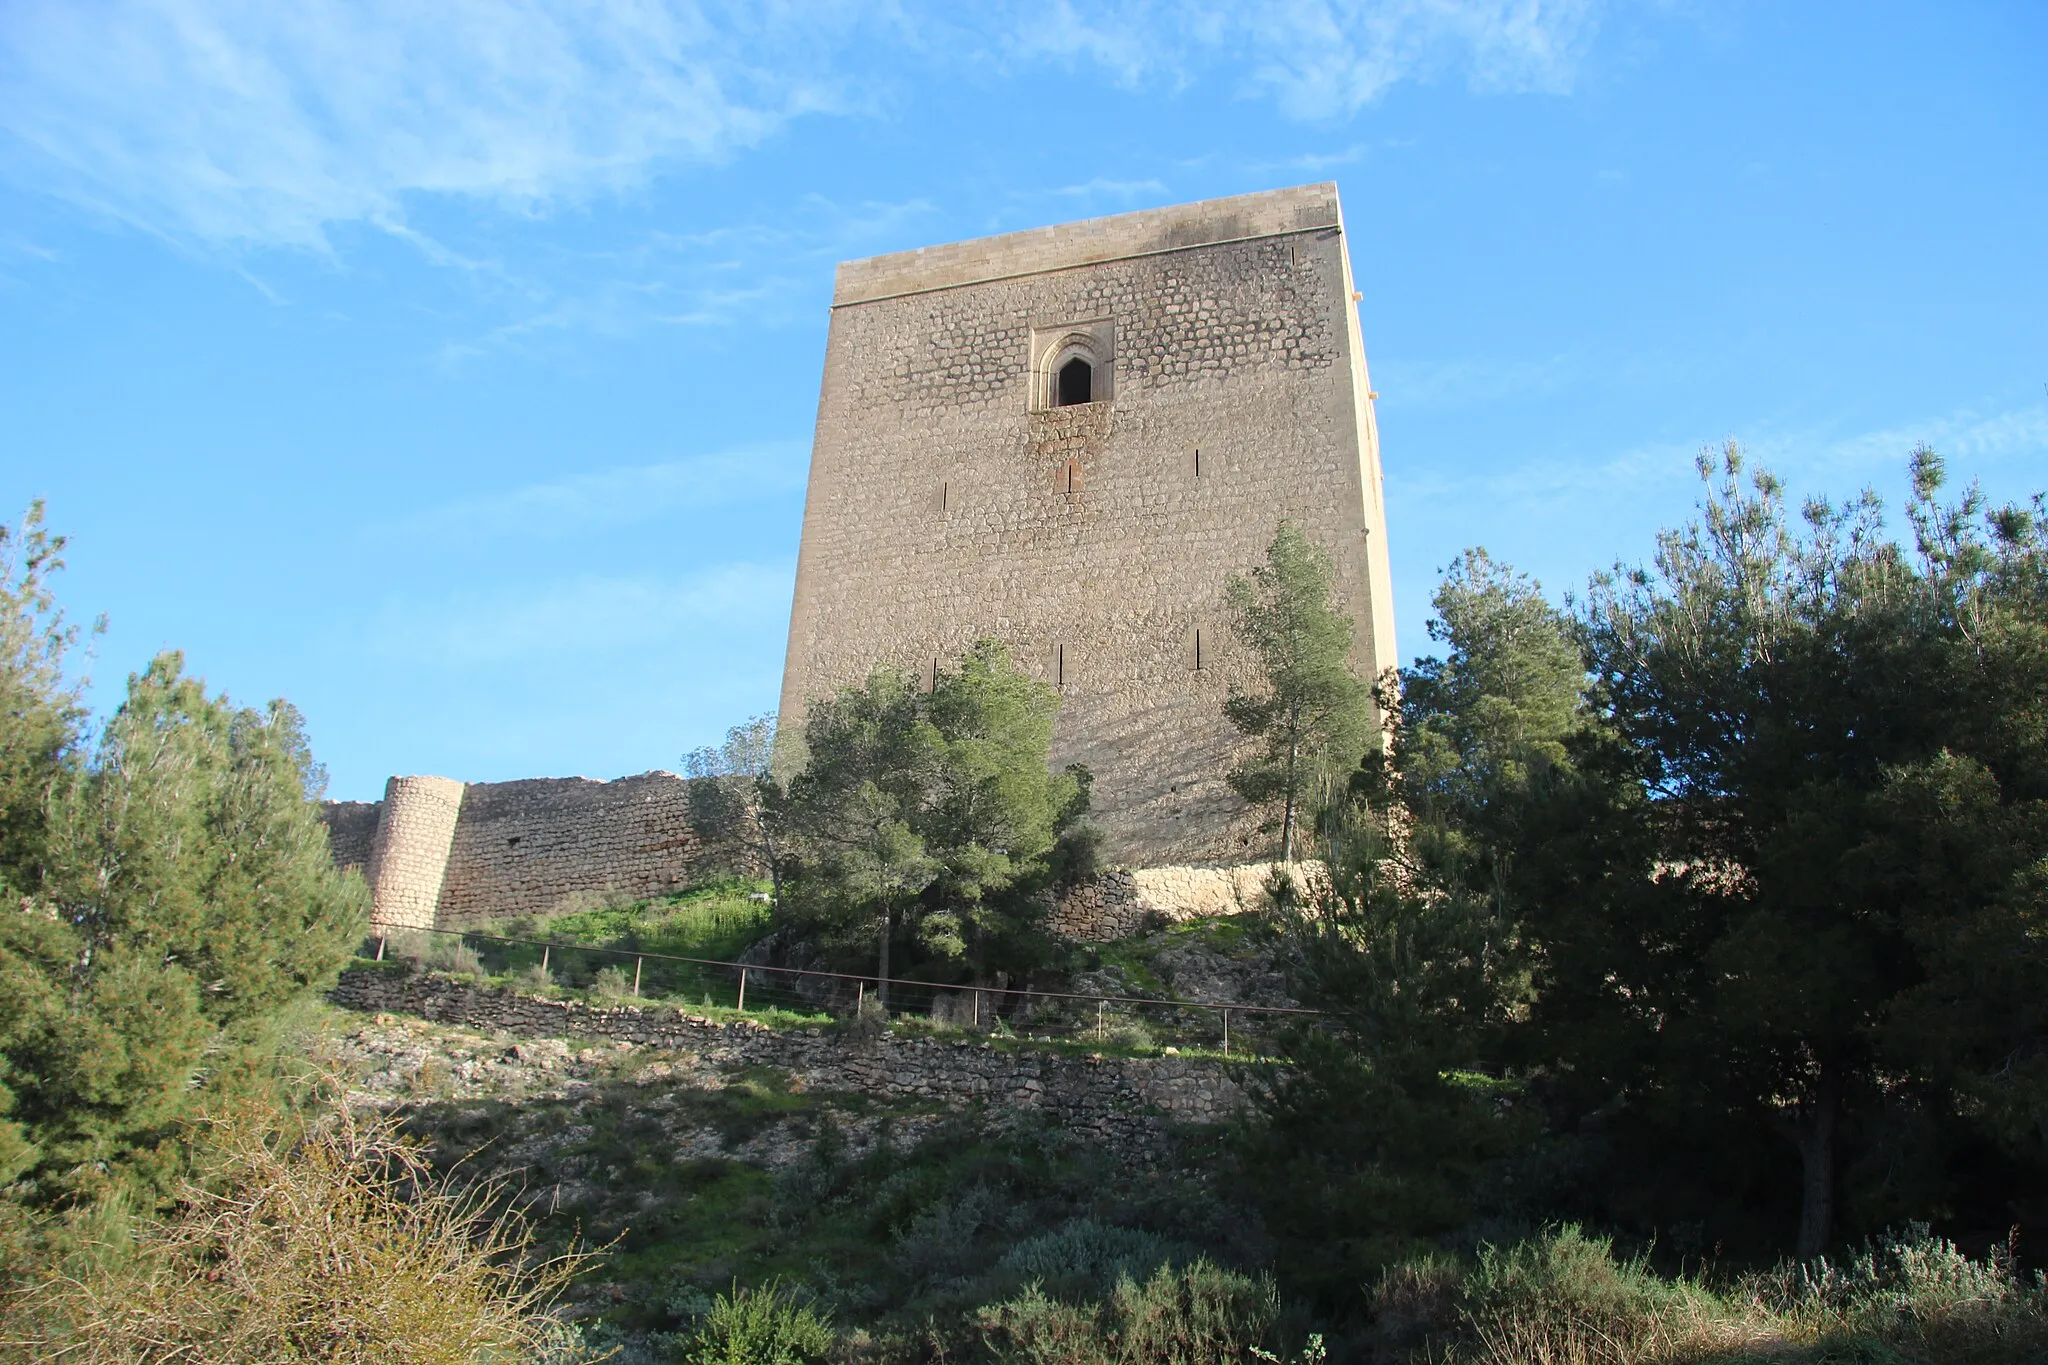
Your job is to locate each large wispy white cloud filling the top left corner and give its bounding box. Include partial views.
[0,0,850,248]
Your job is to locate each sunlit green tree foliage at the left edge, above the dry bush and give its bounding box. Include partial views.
[0,512,367,1199]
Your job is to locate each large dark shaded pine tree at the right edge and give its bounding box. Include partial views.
[1526,448,2048,1257]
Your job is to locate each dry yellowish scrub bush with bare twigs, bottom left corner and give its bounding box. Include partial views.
[0,1105,588,1365]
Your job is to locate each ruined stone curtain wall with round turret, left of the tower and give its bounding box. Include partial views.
[322,772,750,929]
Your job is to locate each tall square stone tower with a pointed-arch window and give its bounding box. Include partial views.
[782,184,1395,864]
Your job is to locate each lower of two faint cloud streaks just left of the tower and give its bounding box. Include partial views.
[367,563,797,669]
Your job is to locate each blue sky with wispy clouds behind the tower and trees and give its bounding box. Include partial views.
[0,0,2048,798]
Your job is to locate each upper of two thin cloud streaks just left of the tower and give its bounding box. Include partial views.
[371,442,805,544]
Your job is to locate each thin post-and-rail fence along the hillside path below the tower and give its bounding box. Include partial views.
[358,929,1321,1056]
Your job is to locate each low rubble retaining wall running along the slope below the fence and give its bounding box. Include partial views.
[330,968,1245,1146]
